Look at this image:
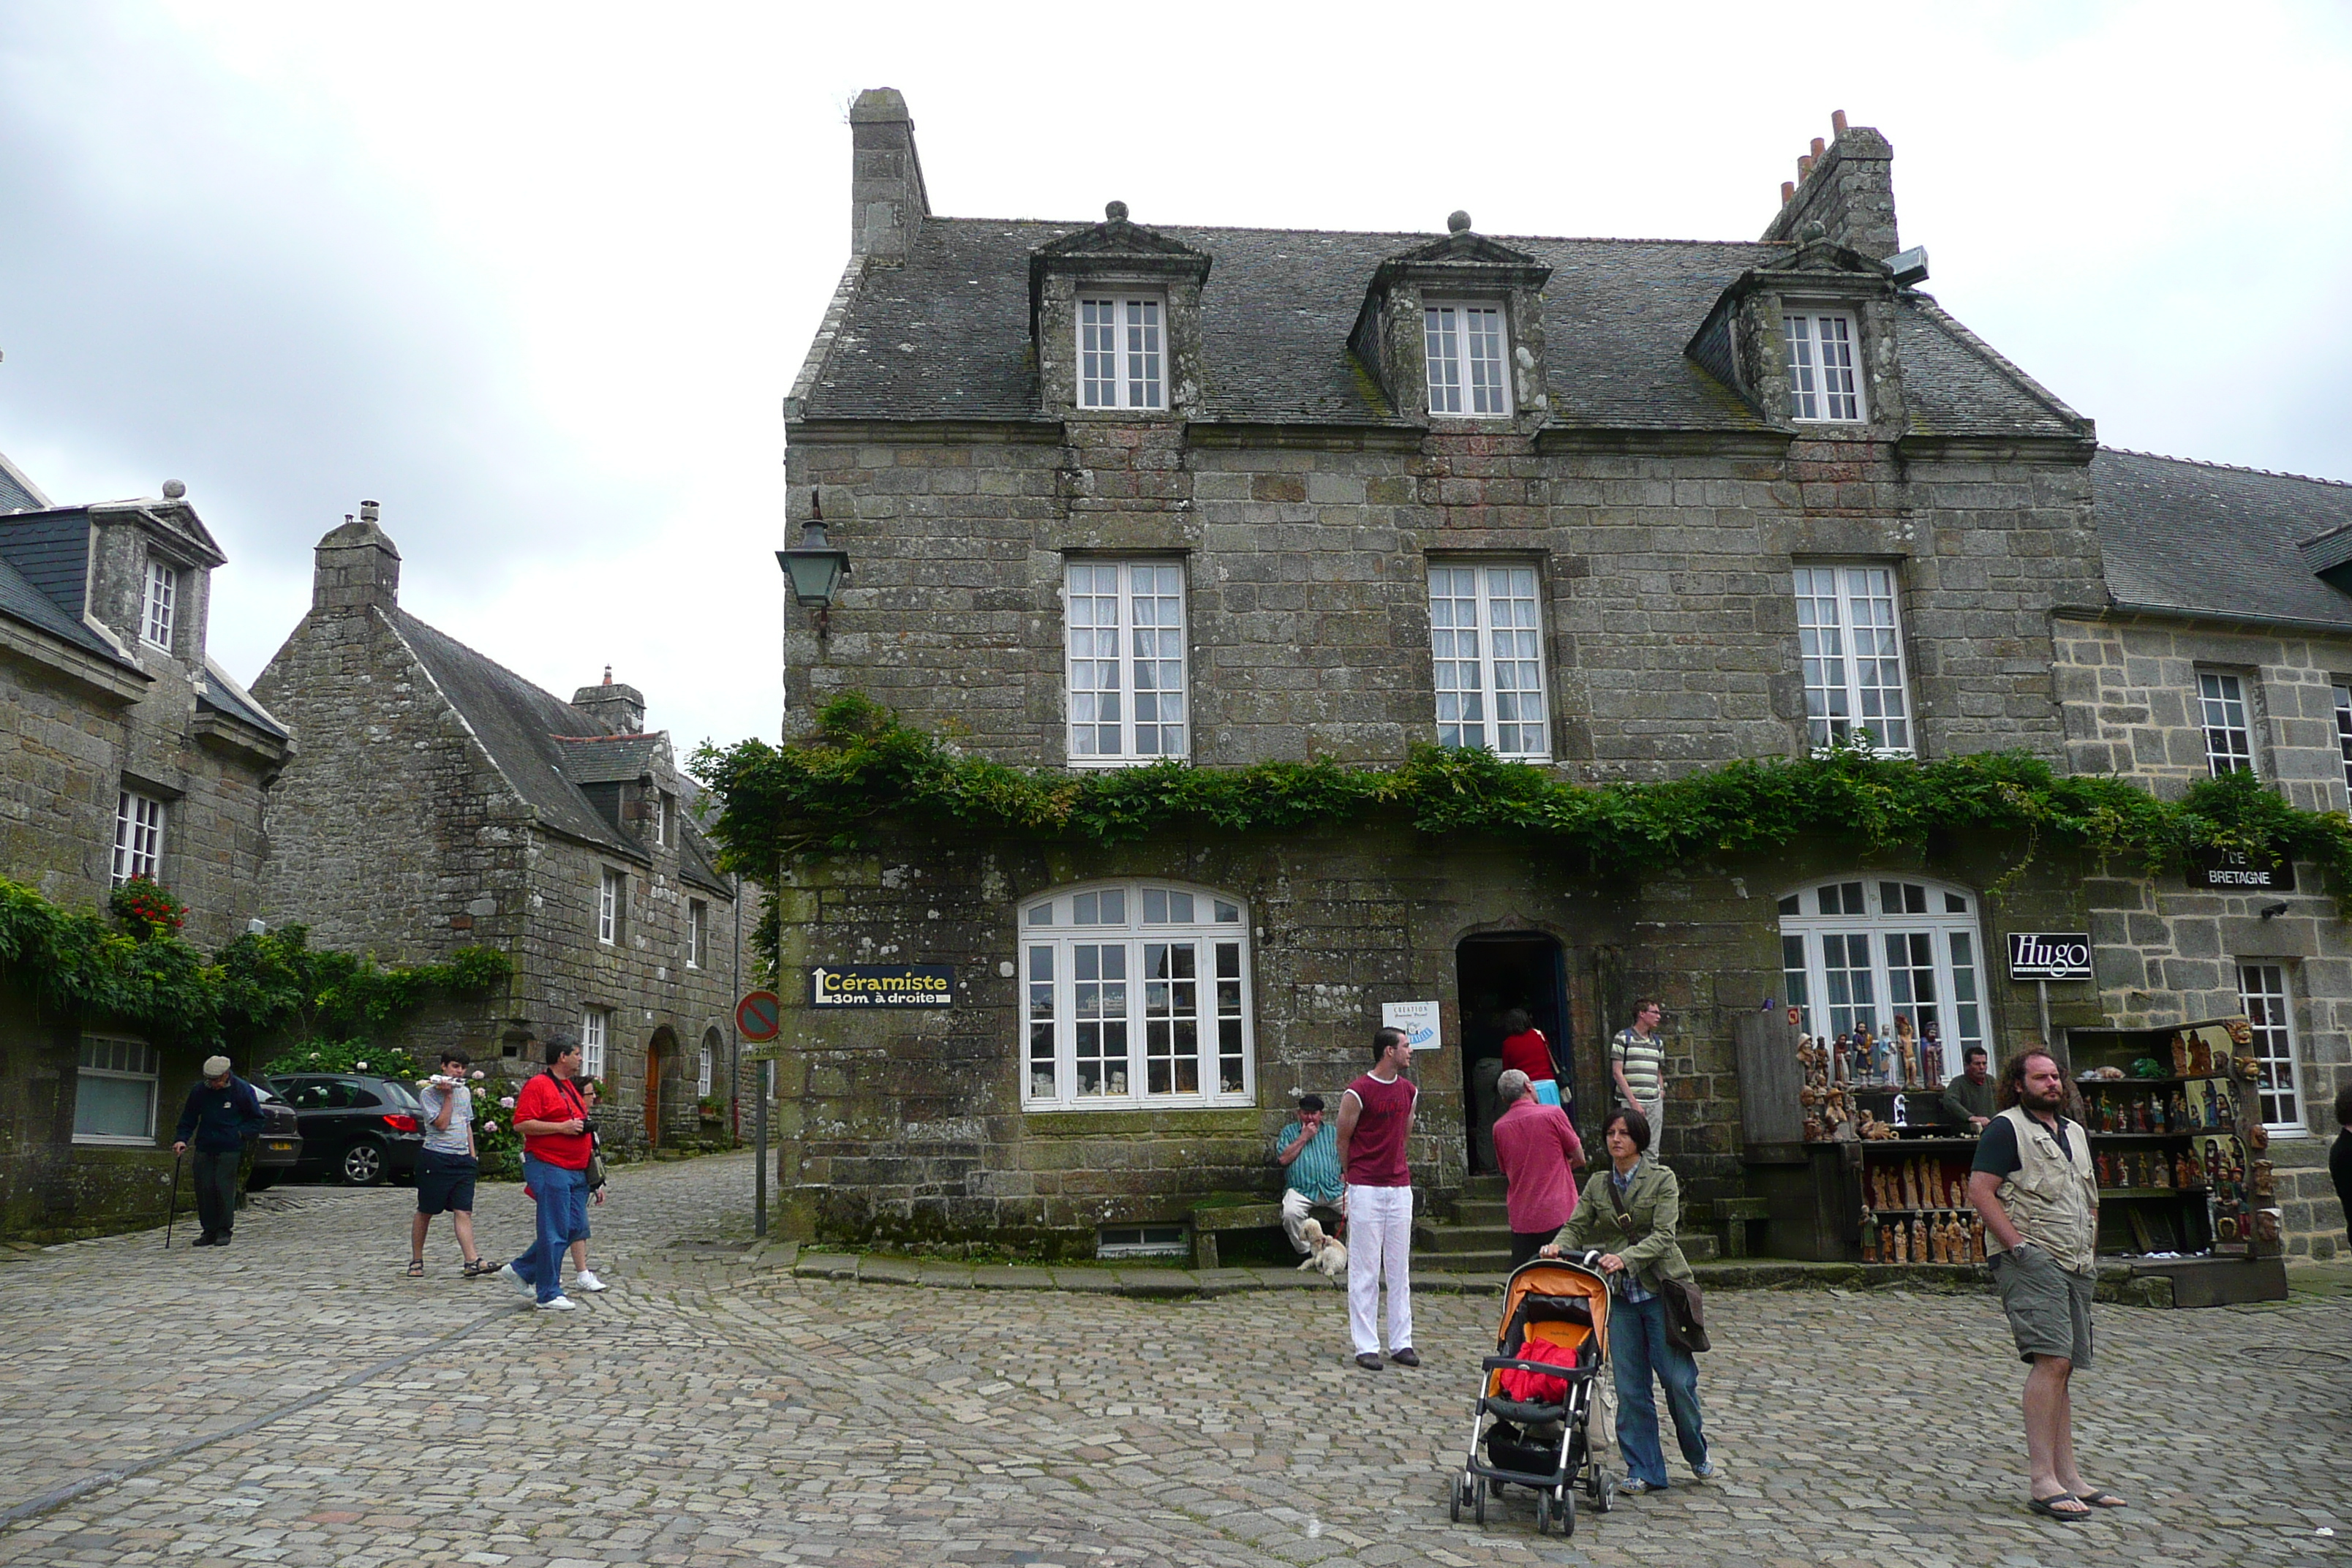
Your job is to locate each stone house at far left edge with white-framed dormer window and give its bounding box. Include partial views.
[0,459,290,1235]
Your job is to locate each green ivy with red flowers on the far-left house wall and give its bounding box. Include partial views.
[0,877,515,1046]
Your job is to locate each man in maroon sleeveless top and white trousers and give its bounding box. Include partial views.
[1338,1030,1420,1373]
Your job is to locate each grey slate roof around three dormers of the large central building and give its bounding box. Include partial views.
[802,219,2084,435]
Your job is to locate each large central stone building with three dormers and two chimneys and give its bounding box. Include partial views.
[778,89,2342,1251]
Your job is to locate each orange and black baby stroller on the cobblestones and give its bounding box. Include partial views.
[1453,1253,1616,1535]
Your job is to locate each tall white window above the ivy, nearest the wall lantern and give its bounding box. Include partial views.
[1063,562,1190,766]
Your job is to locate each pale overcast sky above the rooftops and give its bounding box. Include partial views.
[0,0,2352,747]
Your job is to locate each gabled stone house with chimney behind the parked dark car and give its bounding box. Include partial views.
[254,501,741,1147]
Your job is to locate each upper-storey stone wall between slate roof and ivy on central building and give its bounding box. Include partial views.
[785,421,2098,778]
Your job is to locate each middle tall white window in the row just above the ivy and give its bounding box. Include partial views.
[1430,567,1553,761]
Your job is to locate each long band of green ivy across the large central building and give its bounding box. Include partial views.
[694,696,2352,957]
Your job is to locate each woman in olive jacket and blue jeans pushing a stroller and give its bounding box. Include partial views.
[1543,1109,1714,1495]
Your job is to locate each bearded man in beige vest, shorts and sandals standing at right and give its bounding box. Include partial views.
[1969,1046,2124,1523]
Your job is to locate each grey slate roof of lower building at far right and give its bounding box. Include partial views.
[2091,447,2352,633]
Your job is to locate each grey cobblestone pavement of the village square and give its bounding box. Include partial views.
[0,1156,2352,1568]
